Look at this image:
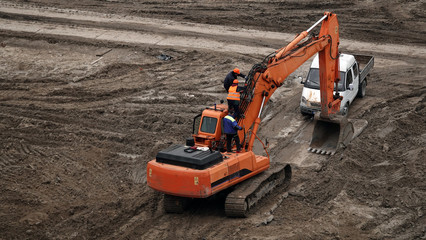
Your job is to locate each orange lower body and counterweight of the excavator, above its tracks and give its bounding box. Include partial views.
[147,152,269,198]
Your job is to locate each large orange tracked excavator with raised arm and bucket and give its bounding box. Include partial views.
[147,12,353,217]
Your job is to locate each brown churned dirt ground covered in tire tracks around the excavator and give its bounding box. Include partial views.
[0,0,426,239]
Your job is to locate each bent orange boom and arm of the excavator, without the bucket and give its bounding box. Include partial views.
[239,12,352,154]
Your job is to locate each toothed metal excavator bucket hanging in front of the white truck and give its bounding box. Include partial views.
[308,112,354,155]
